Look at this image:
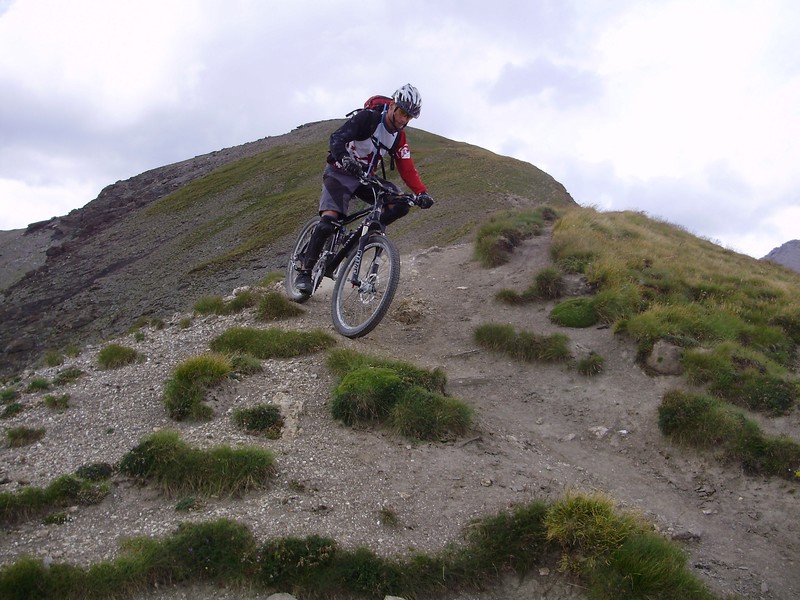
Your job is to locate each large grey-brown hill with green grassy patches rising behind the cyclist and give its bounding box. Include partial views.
[0,120,577,374]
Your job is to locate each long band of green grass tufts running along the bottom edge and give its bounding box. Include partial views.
[0,498,713,600]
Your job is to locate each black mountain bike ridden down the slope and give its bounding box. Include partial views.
[286,175,415,338]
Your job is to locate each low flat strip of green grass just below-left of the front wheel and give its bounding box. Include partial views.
[210,327,336,360]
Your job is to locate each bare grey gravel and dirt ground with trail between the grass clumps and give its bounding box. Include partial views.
[0,236,800,600]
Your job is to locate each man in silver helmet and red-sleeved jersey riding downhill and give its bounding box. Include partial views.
[295,83,433,294]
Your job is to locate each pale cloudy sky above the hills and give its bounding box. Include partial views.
[0,0,800,257]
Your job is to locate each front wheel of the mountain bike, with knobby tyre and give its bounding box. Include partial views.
[331,234,400,338]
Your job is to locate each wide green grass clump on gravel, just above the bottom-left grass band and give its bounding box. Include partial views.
[119,431,274,497]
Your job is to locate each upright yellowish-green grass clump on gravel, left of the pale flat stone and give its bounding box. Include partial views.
[164,354,233,421]
